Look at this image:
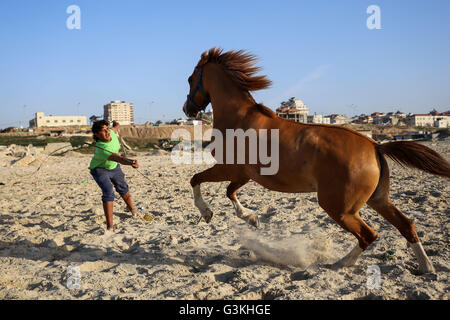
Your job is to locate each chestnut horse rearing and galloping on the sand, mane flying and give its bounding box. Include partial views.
[183,48,450,273]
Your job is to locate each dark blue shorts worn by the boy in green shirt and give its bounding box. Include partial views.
[91,164,128,202]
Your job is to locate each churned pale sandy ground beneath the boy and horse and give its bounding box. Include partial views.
[0,142,450,300]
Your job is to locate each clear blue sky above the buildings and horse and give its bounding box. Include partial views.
[0,0,450,128]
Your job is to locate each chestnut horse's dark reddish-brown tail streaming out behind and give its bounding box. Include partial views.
[376,141,450,178]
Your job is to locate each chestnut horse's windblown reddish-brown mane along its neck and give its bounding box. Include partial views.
[197,47,272,91]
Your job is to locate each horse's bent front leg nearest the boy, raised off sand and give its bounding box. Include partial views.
[191,165,230,223]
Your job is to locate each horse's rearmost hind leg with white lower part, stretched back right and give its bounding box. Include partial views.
[367,196,435,273]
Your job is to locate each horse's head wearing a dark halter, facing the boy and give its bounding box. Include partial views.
[183,53,211,118]
